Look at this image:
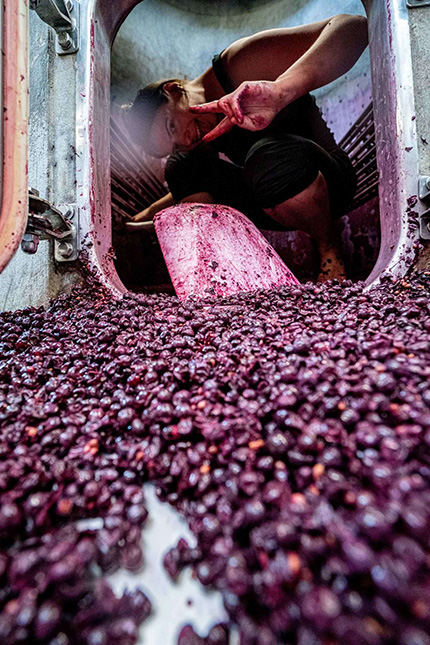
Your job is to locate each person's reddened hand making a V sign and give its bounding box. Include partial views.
[190,81,284,142]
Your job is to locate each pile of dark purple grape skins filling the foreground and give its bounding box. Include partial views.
[0,272,430,645]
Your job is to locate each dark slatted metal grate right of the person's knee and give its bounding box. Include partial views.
[339,102,379,210]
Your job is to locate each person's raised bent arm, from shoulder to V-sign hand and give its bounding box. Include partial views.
[190,14,367,141]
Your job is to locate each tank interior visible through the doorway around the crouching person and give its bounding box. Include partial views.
[111,0,380,291]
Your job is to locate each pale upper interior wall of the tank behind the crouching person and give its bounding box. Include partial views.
[112,0,371,139]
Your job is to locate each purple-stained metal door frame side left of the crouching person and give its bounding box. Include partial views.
[76,0,138,296]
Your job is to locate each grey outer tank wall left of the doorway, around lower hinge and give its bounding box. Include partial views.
[0,11,79,311]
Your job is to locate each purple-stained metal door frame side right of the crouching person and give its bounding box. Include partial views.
[364,0,419,285]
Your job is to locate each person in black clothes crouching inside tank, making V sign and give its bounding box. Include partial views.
[127,14,367,281]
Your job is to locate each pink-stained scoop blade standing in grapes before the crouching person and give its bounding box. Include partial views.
[154,204,299,300]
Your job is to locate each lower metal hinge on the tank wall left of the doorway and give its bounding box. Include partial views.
[21,188,79,262]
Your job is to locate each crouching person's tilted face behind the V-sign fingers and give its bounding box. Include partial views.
[145,85,216,158]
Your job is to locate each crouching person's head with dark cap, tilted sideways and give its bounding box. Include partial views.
[127,79,207,158]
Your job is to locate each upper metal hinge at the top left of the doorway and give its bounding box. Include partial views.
[30,0,80,56]
